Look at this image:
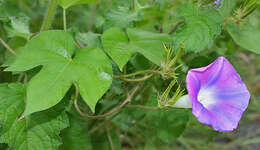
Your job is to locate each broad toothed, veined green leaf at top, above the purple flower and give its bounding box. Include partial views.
[173,4,222,52]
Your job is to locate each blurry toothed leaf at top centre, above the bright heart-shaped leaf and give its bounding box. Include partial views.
[104,7,141,30]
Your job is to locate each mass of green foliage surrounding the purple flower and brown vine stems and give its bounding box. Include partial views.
[0,0,260,150]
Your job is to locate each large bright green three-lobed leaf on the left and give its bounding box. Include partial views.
[6,31,112,116]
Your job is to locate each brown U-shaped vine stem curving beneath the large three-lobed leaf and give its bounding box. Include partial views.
[73,83,141,119]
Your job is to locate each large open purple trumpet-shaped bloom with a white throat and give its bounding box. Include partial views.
[186,57,250,131]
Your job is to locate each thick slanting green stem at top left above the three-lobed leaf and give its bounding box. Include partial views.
[41,0,58,31]
